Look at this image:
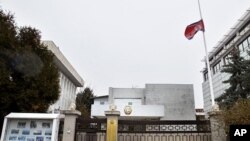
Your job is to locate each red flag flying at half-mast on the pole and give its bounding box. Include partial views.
[185,19,205,40]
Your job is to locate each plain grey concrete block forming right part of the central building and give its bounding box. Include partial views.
[145,84,195,120]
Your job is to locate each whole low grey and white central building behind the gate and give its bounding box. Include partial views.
[91,84,195,120]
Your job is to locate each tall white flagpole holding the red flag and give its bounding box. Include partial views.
[198,0,215,107]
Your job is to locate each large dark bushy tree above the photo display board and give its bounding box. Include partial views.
[0,9,60,127]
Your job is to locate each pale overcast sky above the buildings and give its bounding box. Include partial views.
[0,0,250,108]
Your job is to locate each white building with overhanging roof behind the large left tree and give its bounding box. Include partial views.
[43,41,84,111]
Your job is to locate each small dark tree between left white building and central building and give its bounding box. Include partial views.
[76,87,94,118]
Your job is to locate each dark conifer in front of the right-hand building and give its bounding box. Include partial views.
[216,49,247,108]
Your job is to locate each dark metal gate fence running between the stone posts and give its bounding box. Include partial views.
[75,118,211,141]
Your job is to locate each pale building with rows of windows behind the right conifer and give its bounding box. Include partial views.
[202,8,250,114]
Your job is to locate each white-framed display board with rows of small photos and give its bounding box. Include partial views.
[1,113,59,141]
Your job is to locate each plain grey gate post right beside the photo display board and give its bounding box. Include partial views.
[63,110,81,141]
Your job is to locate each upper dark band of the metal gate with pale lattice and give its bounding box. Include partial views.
[76,118,211,133]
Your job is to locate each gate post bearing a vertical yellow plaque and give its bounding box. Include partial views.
[105,106,120,141]
